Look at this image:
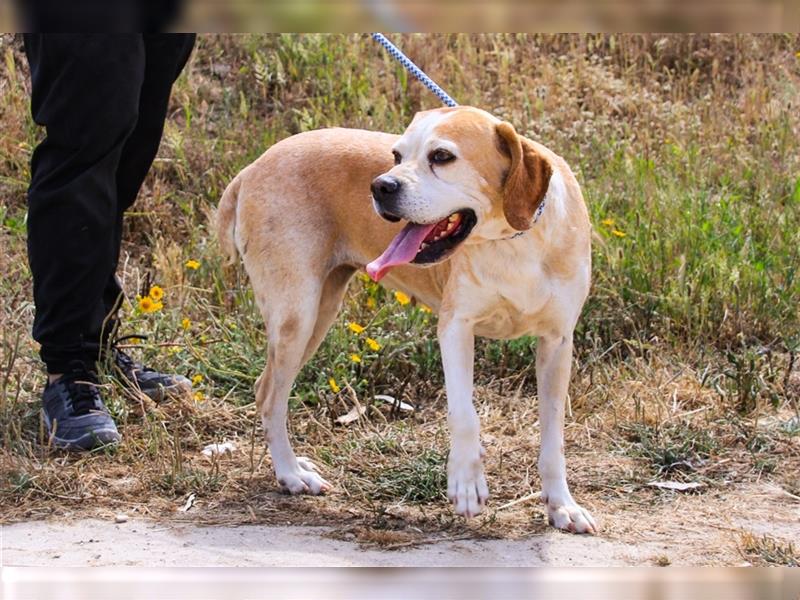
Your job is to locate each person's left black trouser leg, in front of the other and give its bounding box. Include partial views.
[25,34,146,373]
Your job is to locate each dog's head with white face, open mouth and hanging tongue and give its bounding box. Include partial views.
[367,107,552,281]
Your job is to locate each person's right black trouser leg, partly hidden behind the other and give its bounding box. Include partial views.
[103,33,195,334]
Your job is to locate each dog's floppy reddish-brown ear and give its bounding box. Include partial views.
[496,121,553,231]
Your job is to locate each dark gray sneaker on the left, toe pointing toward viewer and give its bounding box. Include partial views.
[42,363,121,450]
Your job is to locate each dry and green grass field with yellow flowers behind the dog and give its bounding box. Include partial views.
[0,34,800,556]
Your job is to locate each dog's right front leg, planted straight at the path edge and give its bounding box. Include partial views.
[536,334,597,533]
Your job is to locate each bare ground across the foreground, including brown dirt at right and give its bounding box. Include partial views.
[2,484,800,567]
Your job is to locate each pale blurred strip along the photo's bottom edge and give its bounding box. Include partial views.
[0,569,800,600]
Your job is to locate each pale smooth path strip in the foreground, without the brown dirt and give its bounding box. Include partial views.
[0,519,659,567]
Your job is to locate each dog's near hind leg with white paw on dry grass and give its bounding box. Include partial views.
[256,282,331,494]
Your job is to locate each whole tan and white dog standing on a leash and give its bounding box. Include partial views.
[217,107,596,533]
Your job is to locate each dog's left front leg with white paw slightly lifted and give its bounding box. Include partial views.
[438,315,489,518]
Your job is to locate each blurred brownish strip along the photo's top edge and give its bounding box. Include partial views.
[0,0,798,32]
